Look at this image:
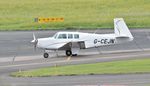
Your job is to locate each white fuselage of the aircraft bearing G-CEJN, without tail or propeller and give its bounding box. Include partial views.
[37,32,116,50]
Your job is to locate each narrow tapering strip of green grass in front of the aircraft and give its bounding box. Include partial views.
[11,59,150,77]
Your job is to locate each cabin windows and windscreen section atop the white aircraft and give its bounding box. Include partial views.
[53,32,79,39]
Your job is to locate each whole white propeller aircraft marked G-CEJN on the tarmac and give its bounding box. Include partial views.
[31,18,134,58]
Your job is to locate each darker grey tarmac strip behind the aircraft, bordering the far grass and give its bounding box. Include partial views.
[0,29,150,58]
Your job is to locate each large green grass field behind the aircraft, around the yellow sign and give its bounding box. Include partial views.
[0,0,150,30]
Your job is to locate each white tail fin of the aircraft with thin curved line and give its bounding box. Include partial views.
[114,18,133,40]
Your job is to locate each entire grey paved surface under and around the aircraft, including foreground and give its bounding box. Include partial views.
[0,29,150,86]
